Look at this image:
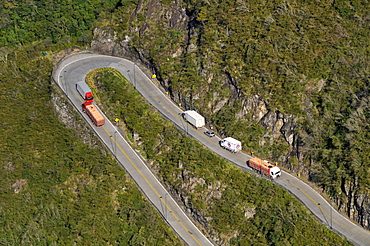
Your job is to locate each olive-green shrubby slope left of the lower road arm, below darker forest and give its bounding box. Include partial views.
[0,22,181,245]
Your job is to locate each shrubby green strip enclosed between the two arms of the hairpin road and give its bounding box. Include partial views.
[87,69,349,245]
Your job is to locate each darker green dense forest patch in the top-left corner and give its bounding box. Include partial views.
[0,0,120,47]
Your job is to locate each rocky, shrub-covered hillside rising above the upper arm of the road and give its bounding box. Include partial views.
[92,0,370,228]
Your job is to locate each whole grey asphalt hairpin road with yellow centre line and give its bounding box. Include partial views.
[53,52,370,246]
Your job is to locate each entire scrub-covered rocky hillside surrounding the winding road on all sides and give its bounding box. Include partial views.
[0,0,369,245]
